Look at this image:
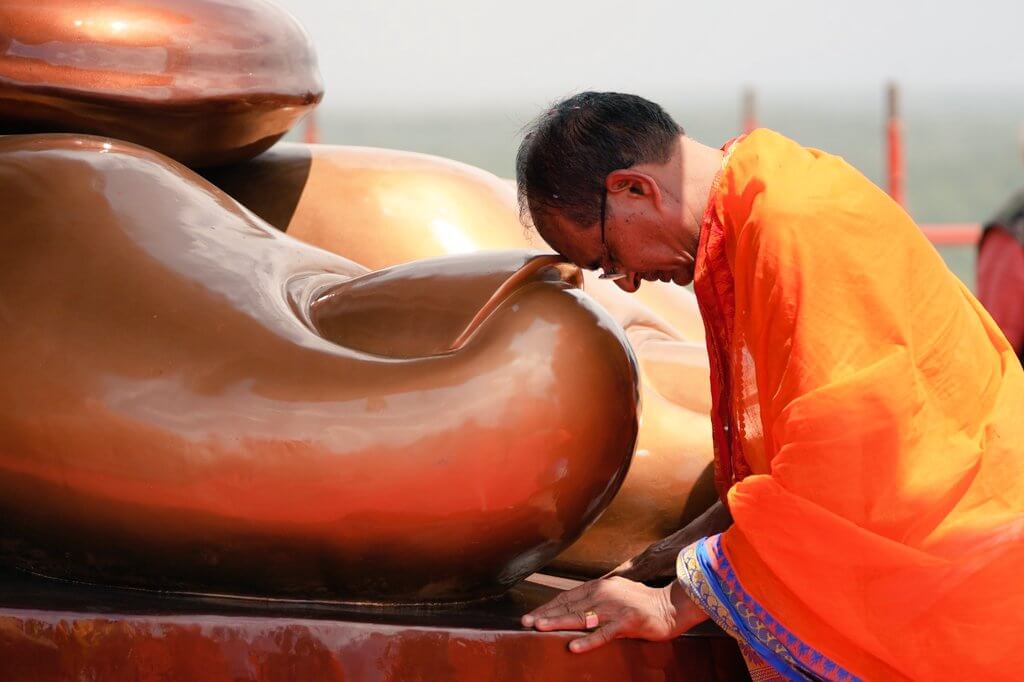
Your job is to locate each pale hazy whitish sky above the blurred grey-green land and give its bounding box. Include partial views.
[278,0,1024,110]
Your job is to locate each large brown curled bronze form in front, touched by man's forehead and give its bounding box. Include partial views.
[0,135,638,601]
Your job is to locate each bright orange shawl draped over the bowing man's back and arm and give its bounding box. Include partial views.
[694,130,1024,680]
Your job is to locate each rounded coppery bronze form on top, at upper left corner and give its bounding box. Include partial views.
[0,0,324,166]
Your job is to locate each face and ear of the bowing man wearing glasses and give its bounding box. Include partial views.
[537,180,696,292]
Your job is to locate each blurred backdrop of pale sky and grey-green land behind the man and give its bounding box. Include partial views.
[279,0,1024,286]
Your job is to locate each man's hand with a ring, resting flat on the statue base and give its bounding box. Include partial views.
[522,578,708,653]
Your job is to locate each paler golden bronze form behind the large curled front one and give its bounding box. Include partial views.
[207,143,716,577]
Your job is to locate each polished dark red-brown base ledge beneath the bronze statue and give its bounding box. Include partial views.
[0,572,749,682]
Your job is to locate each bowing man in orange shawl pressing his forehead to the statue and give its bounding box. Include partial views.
[517,92,1024,680]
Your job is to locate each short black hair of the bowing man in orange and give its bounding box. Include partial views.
[515,92,683,225]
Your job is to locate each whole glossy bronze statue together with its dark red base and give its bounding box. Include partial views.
[0,0,757,681]
